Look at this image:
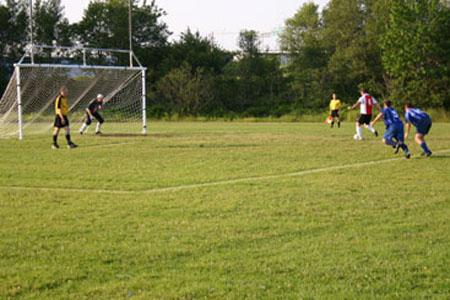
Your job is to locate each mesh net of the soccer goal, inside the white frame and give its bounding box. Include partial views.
[0,65,143,138]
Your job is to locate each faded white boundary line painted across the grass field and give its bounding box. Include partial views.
[0,149,450,195]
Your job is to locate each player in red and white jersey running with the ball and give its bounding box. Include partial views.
[347,89,381,140]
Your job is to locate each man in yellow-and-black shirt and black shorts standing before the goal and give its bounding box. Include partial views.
[52,87,78,149]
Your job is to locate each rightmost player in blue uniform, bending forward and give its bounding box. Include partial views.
[405,102,432,156]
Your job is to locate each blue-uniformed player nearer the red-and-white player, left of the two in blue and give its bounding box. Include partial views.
[371,100,411,158]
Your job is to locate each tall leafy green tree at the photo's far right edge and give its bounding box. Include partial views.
[383,0,450,109]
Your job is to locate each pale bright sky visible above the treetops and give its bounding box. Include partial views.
[62,0,328,50]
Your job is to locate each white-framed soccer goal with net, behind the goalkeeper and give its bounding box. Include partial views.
[0,46,146,139]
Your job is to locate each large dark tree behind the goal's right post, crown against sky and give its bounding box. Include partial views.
[73,0,170,87]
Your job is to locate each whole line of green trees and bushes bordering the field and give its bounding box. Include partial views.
[0,0,450,118]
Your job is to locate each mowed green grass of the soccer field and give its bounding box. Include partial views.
[0,122,450,299]
